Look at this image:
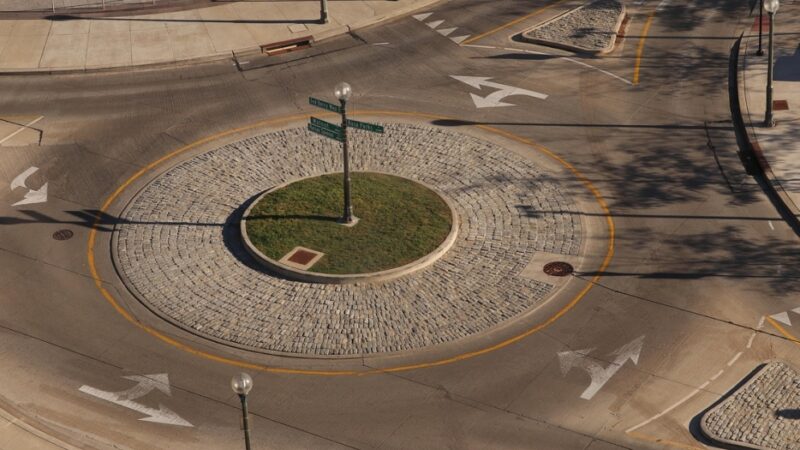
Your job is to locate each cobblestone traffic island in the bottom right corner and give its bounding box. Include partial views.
[701,361,800,450]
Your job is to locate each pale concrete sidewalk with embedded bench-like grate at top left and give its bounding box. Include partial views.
[0,0,438,73]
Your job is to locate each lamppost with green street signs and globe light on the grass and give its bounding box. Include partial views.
[308,83,383,225]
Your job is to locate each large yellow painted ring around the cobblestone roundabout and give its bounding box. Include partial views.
[87,110,615,376]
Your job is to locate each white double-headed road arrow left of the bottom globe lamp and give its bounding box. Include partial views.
[79,373,194,427]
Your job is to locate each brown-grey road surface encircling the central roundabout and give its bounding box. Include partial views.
[0,0,800,450]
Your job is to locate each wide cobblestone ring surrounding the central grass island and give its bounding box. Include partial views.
[112,124,581,357]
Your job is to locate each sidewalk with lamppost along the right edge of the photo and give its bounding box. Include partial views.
[738,2,800,225]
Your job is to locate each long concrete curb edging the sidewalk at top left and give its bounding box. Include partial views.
[0,0,442,76]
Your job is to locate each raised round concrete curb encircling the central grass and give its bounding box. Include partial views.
[239,171,460,284]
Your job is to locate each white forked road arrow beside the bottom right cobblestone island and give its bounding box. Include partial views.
[558,335,644,400]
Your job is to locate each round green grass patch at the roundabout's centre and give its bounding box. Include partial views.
[247,172,452,274]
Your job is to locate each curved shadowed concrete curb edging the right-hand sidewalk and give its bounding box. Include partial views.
[730,36,800,230]
